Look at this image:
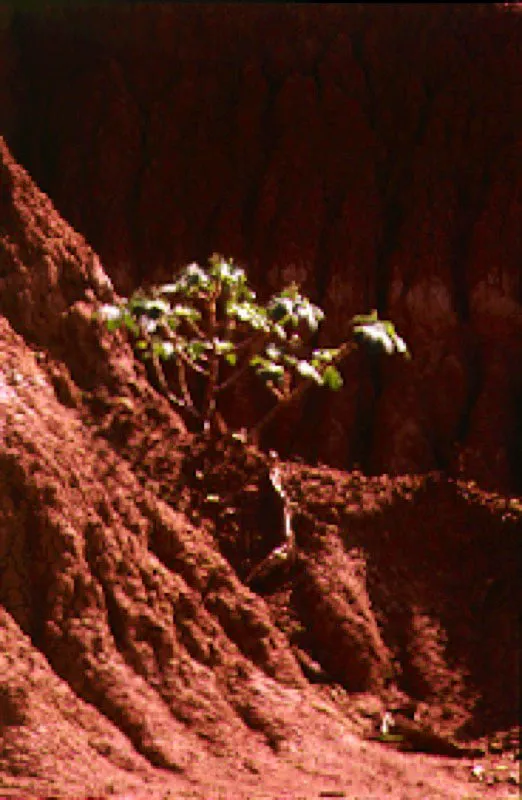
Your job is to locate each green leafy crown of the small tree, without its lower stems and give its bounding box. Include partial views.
[97,260,410,432]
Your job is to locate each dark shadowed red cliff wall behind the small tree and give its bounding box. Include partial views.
[0,4,522,491]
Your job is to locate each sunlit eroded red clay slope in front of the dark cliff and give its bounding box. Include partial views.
[0,143,522,800]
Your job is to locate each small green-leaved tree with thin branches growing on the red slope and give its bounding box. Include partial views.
[96,254,409,435]
